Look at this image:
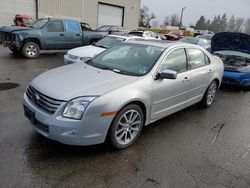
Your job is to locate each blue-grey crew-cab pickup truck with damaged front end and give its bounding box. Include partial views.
[0,18,128,59]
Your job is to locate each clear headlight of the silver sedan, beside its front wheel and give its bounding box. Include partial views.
[63,96,96,120]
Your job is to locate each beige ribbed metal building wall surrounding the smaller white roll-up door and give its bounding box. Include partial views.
[38,0,141,29]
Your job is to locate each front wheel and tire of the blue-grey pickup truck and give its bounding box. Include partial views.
[22,42,40,59]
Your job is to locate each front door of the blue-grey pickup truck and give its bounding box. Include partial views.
[43,20,67,49]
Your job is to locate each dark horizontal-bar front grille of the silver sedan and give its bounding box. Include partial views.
[26,86,64,114]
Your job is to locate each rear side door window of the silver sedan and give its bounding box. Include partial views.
[187,49,206,69]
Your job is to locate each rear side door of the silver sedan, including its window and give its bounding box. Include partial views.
[186,48,213,104]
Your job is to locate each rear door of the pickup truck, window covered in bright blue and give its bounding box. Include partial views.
[64,20,82,49]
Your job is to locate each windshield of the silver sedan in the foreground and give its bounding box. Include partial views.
[86,43,165,76]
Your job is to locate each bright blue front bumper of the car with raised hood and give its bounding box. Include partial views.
[222,71,250,87]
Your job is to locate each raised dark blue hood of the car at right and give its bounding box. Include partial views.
[211,32,250,54]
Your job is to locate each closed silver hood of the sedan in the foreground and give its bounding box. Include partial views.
[31,63,138,101]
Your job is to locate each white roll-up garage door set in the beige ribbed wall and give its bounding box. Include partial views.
[98,3,124,27]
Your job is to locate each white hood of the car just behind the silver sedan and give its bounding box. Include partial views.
[68,45,106,57]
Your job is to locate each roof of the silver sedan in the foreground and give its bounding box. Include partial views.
[126,39,200,49]
